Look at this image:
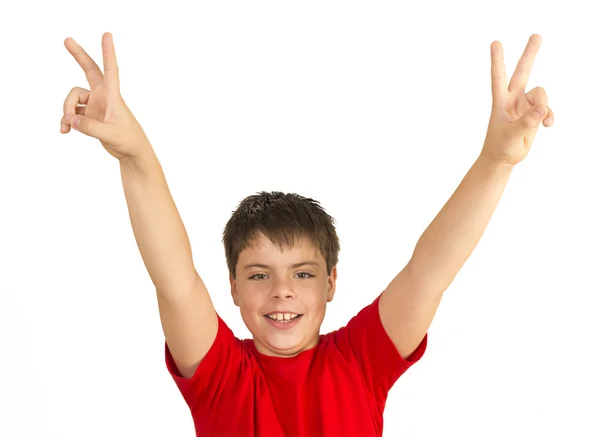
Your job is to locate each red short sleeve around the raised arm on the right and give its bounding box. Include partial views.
[344,295,427,399]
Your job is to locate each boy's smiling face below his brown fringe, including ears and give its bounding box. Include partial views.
[230,234,337,357]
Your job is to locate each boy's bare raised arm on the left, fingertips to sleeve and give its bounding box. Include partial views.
[61,33,218,377]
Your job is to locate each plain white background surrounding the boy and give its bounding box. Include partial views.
[0,1,600,437]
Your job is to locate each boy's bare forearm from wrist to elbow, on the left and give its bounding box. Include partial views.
[120,146,196,293]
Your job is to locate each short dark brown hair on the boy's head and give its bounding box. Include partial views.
[223,191,340,279]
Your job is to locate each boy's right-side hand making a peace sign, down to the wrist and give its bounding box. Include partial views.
[482,35,554,165]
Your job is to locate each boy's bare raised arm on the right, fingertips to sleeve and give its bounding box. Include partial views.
[379,35,554,358]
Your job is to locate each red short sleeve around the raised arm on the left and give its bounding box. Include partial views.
[165,316,244,415]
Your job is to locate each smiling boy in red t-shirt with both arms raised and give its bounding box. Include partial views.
[61,33,553,437]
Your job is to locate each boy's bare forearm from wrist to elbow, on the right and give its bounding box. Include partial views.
[409,156,513,292]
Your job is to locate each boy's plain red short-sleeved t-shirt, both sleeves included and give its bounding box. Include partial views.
[165,297,427,437]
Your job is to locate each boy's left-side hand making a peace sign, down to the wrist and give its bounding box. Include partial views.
[60,32,150,159]
